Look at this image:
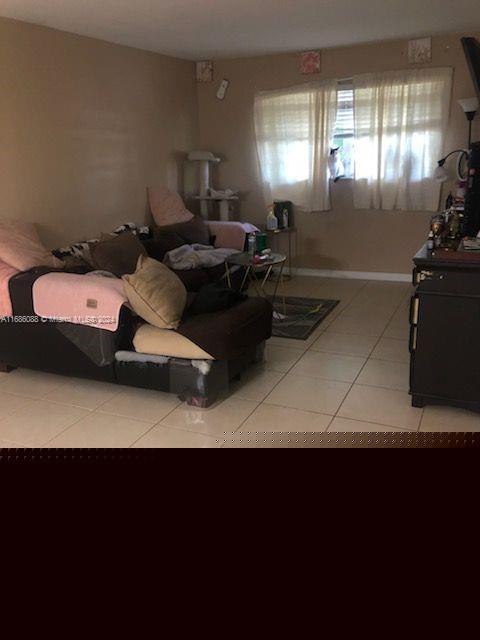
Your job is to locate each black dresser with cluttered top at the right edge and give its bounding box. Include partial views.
[410,246,480,411]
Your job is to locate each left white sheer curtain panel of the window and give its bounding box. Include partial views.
[254,80,337,211]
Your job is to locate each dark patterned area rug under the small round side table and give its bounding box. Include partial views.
[269,296,340,340]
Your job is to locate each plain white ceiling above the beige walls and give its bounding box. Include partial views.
[0,0,480,60]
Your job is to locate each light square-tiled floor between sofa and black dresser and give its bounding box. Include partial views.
[0,277,480,448]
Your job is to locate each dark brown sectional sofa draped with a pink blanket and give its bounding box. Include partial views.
[0,232,272,407]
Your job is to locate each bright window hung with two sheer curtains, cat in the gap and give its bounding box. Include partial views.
[254,68,452,211]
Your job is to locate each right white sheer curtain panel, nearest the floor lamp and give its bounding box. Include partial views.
[353,68,452,211]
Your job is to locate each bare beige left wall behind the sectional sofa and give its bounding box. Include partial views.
[0,18,198,246]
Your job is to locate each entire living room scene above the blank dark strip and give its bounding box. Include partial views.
[0,0,480,449]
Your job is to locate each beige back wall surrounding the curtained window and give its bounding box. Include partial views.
[198,34,480,273]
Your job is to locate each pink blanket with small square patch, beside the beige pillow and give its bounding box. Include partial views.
[33,273,127,331]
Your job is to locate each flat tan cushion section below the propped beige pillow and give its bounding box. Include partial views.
[133,324,213,360]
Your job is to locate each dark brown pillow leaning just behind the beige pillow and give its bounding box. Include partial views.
[90,232,147,278]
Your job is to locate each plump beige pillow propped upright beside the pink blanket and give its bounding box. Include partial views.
[122,256,187,329]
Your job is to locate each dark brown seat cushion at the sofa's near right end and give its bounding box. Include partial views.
[176,298,273,360]
